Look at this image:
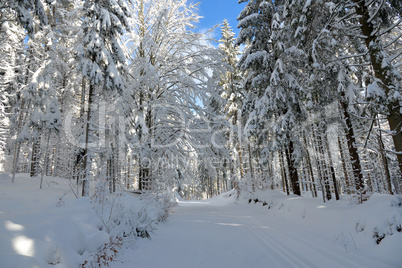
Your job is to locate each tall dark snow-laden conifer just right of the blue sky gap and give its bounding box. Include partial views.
[237,1,307,195]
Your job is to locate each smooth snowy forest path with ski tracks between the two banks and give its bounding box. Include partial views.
[112,197,390,268]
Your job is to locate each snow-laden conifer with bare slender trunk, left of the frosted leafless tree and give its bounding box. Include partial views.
[77,0,129,196]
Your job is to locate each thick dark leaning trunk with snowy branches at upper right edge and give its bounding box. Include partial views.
[352,0,402,173]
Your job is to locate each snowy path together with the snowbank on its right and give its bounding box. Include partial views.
[111,191,402,268]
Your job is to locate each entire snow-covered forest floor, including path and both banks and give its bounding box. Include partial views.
[0,175,402,268]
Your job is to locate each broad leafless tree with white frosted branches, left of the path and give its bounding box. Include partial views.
[123,0,220,191]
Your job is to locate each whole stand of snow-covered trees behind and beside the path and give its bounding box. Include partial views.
[0,0,402,267]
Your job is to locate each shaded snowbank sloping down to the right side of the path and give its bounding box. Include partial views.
[242,191,402,267]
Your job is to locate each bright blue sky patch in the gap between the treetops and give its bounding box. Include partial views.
[188,0,245,38]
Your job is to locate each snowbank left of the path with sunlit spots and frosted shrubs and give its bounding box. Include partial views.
[0,174,170,268]
